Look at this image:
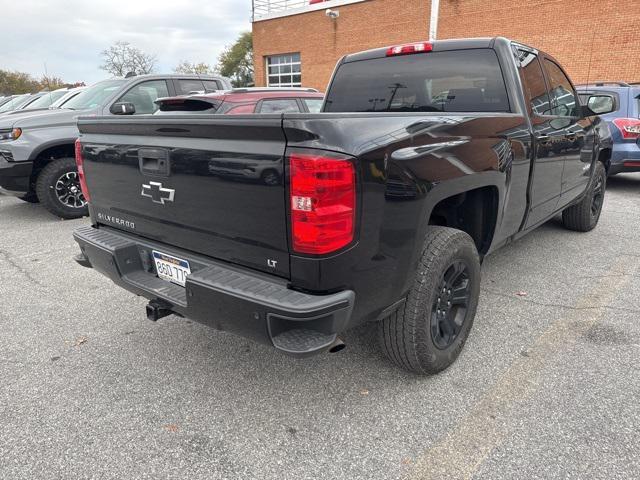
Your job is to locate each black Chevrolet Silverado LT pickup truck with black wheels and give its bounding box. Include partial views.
[74,38,610,374]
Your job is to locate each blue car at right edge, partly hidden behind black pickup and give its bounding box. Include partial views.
[577,82,640,175]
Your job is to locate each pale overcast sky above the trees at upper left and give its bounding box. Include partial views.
[0,0,251,83]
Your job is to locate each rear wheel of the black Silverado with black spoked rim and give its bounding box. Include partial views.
[378,226,480,375]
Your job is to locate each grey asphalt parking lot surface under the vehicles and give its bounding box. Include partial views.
[0,174,640,480]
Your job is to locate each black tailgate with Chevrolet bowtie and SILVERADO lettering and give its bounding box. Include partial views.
[79,115,289,278]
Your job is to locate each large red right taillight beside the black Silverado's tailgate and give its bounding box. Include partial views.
[289,152,356,255]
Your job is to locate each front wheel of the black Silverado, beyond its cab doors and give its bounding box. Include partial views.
[562,162,607,232]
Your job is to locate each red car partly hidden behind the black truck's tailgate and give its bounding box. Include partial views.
[156,88,324,115]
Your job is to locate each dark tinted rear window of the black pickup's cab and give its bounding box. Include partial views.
[324,49,510,112]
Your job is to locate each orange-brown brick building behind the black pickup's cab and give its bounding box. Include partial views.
[253,0,640,90]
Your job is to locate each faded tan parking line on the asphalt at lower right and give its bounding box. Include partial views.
[410,256,637,480]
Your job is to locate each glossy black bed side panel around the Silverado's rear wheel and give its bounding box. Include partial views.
[284,113,531,320]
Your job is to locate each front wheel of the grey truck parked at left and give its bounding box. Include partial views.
[36,158,89,219]
